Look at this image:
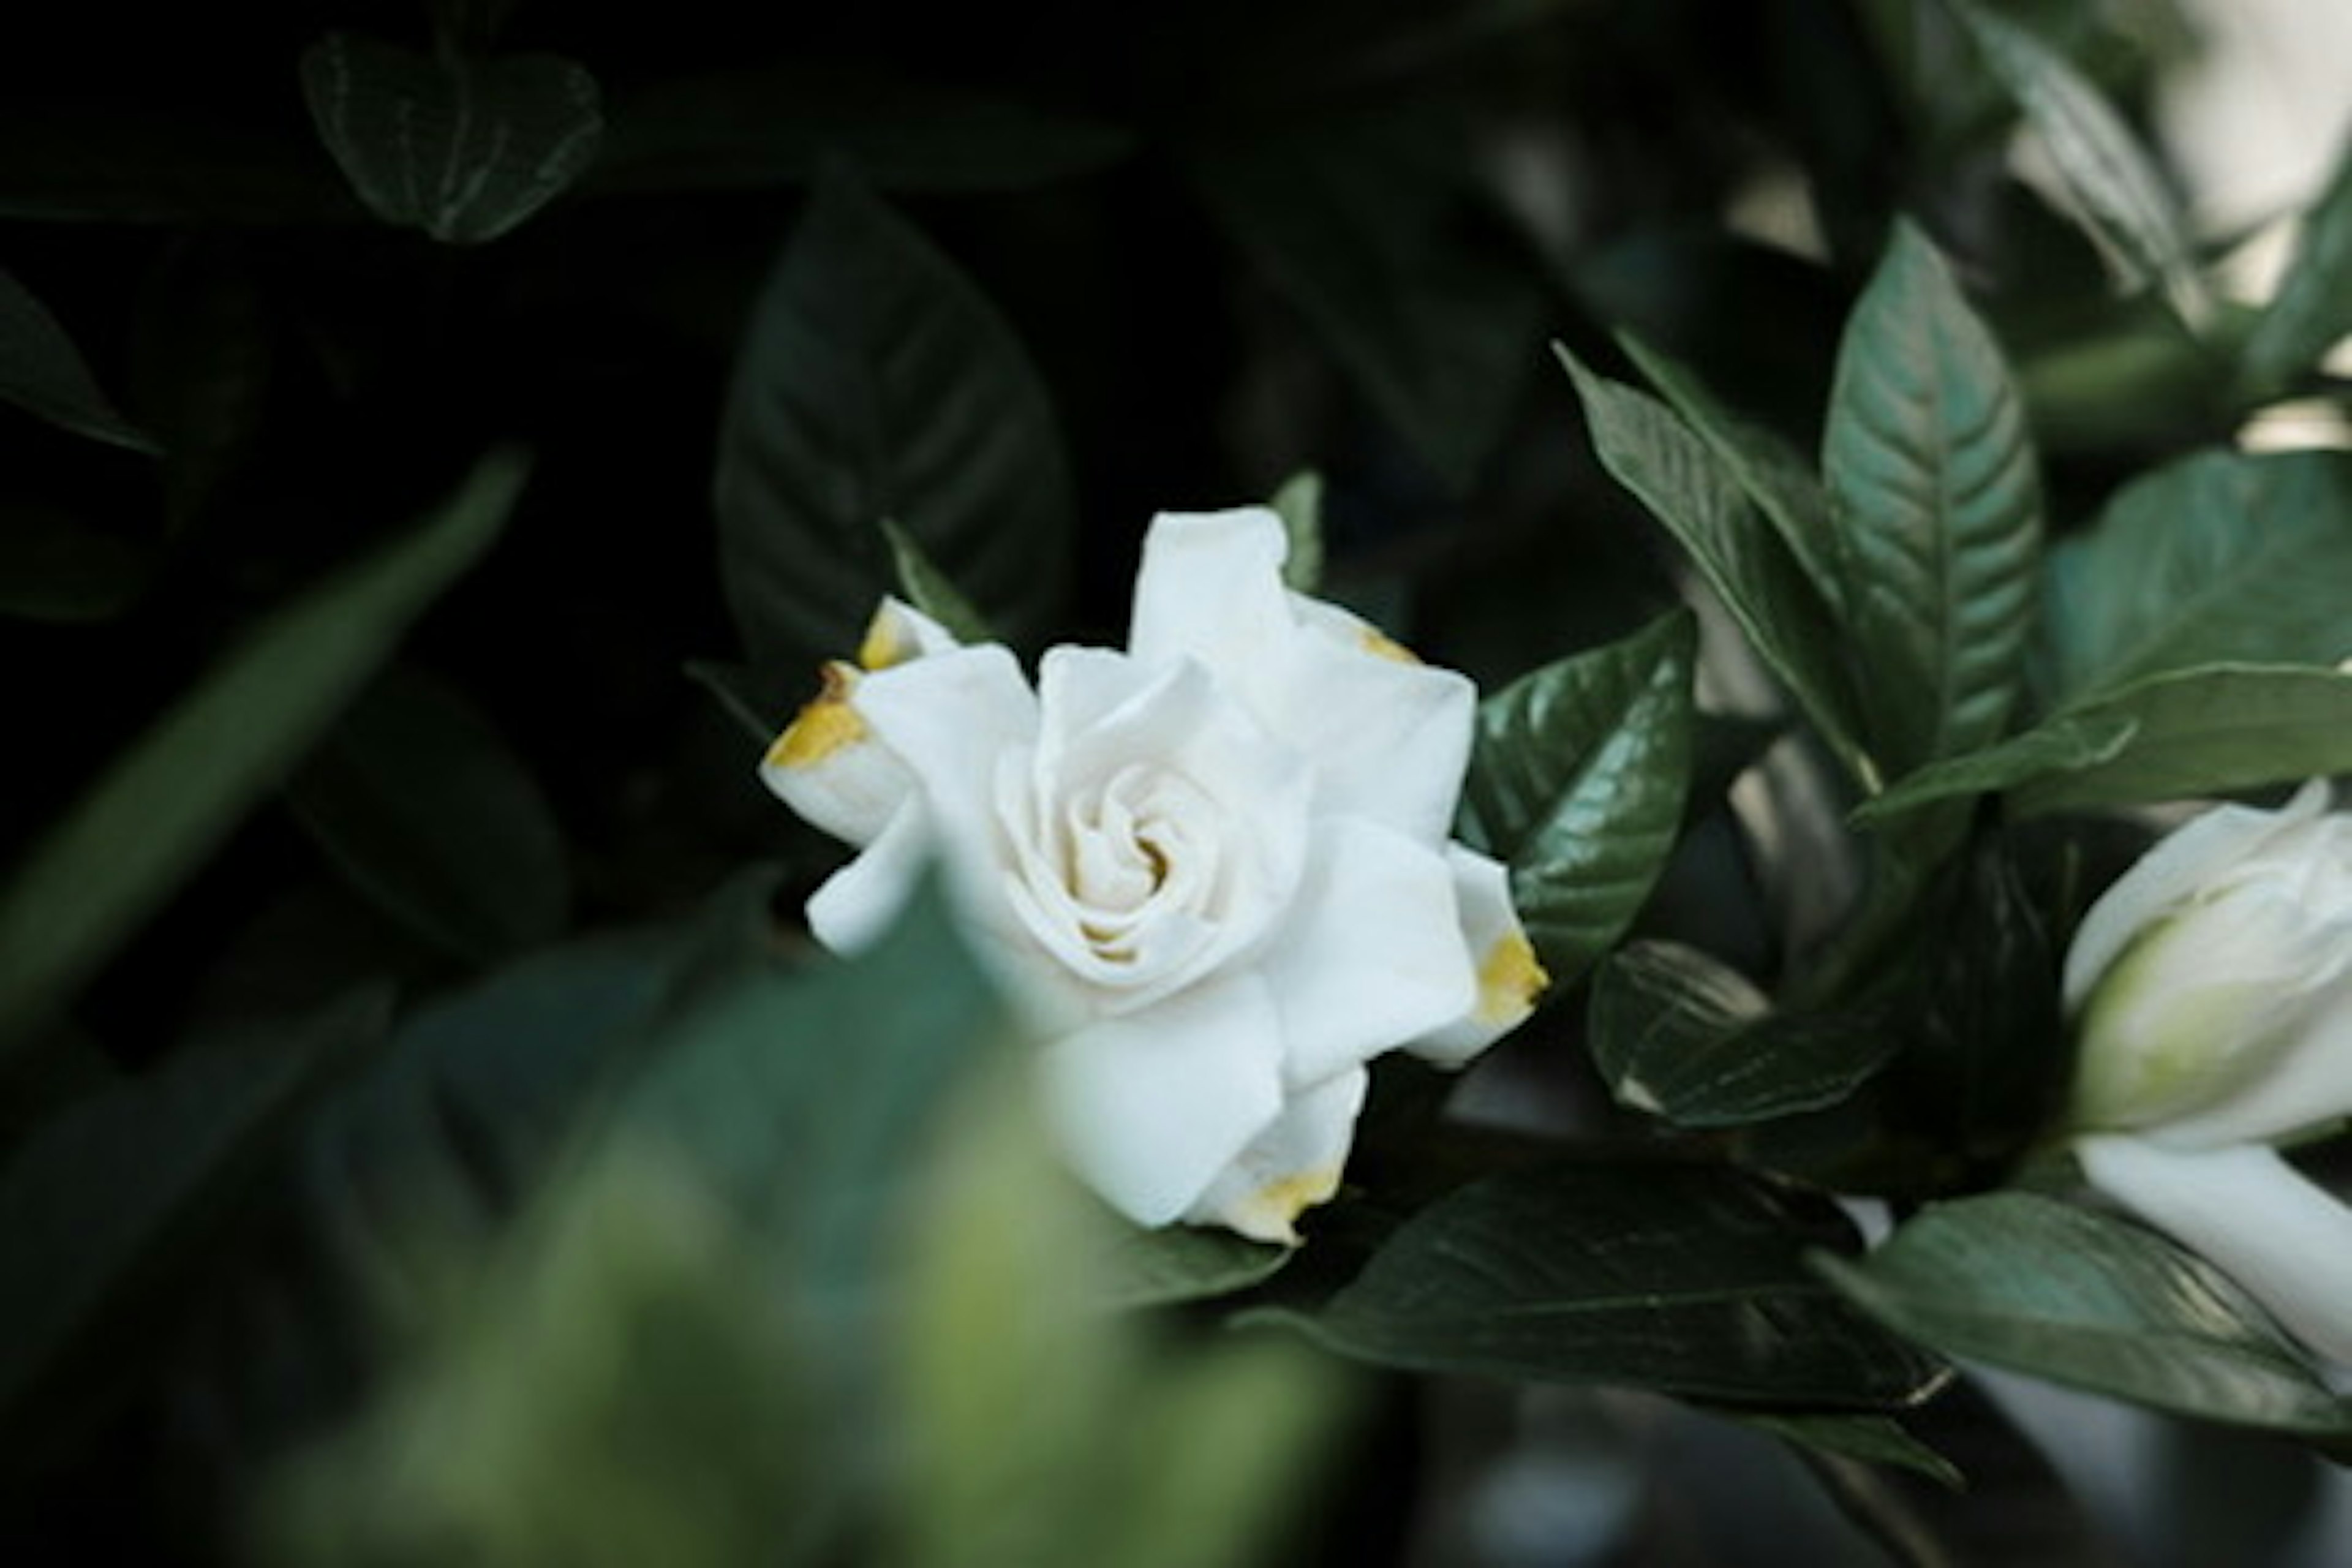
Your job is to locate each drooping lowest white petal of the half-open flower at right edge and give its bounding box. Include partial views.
[2075,1136,2352,1366]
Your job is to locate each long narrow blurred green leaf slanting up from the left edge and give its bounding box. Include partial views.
[0,451,527,1065]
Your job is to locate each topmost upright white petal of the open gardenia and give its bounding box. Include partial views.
[1126,505,1296,675]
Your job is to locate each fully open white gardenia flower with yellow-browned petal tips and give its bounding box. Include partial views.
[760,508,1545,1242]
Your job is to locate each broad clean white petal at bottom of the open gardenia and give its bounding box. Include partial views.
[1044,976,1282,1225]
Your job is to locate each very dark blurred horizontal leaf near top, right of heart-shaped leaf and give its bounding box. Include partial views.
[586,61,1131,193]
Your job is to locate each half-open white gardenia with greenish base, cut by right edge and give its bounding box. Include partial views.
[2065,780,2352,1366]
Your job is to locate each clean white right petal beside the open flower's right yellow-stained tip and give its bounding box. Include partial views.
[1261,818,1477,1084]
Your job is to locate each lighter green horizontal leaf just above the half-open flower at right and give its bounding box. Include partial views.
[2013,665,2352,811]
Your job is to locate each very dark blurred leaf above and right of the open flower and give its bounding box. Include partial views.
[1190,99,1545,486]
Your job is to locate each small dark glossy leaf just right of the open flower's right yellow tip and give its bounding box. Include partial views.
[1588,943,1898,1126]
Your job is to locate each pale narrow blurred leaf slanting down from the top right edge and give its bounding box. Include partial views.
[1948,0,2213,326]
